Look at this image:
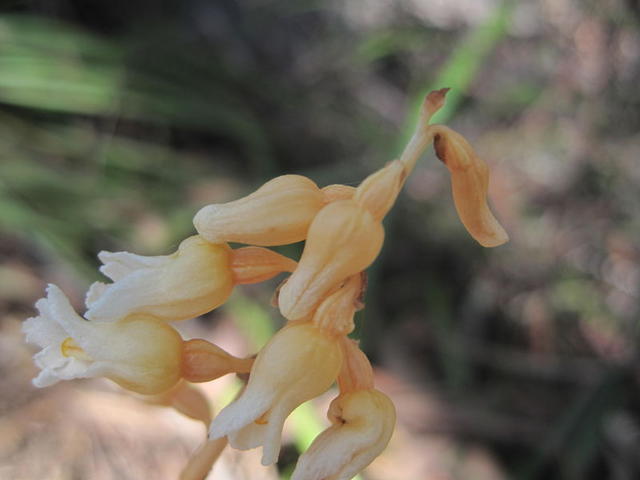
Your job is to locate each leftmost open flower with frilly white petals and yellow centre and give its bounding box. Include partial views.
[23,285,182,394]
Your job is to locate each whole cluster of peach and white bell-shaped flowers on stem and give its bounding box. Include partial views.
[24,89,508,480]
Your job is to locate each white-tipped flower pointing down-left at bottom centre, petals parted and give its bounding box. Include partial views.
[210,322,342,465]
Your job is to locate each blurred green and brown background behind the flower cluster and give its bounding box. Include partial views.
[0,0,640,480]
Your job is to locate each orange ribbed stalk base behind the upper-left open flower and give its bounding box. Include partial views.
[231,247,297,284]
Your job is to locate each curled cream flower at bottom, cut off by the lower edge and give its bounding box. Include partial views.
[291,389,396,480]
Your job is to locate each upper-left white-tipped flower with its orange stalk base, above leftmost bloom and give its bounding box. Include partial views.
[86,235,296,322]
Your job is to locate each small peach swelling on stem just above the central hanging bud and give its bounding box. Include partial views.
[353,160,407,220]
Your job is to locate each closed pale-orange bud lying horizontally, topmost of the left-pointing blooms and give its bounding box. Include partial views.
[193,175,323,246]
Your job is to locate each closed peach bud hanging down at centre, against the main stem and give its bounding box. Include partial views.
[278,200,384,320]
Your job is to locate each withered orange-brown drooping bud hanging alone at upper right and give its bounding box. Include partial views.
[431,125,509,247]
